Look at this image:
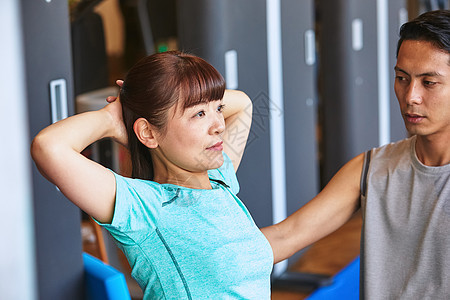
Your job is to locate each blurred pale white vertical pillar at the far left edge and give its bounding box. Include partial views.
[0,0,37,300]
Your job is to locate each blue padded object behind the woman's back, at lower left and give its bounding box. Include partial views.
[83,253,131,300]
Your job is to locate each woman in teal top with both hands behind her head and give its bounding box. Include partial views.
[31,52,273,299]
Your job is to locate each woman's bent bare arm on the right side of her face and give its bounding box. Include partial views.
[223,90,253,171]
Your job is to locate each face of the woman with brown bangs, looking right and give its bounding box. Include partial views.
[154,100,225,172]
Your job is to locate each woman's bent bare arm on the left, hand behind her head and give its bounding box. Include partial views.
[31,101,126,223]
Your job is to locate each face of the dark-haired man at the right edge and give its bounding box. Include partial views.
[394,40,450,141]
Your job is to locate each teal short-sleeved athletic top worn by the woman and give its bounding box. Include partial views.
[100,153,273,300]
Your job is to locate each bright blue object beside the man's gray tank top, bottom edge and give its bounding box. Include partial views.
[307,256,359,300]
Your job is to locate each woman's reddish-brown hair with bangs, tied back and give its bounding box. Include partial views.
[120,51,225,180]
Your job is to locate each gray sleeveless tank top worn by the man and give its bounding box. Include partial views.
[360,136,450,300]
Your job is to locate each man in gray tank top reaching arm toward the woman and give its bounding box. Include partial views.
[262,10,450,299]
